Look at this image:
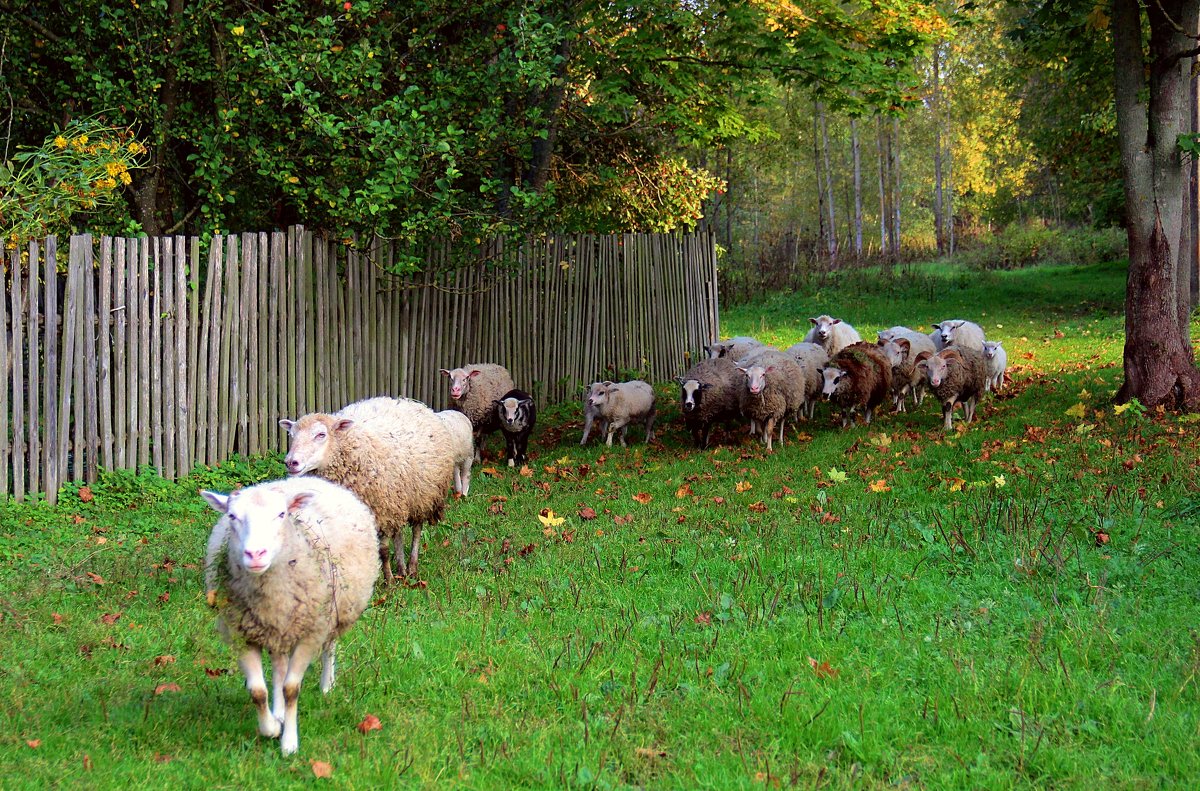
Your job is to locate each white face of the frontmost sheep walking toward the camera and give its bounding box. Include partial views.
[200,489,313,575]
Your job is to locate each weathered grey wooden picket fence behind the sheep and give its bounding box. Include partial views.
[0,228,718,502]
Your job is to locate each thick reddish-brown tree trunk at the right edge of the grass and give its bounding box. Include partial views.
[1112,0,1200,408]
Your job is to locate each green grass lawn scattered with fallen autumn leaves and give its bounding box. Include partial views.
[0,256,1200,789]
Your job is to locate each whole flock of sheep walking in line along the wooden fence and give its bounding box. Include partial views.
[203,316,1006,755]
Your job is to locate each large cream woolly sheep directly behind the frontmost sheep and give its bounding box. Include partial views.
[280,397,453,582]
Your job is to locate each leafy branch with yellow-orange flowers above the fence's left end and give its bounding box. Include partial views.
[0,119,146,244]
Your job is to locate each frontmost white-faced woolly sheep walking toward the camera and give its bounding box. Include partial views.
[202,477,379,755]
